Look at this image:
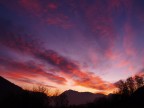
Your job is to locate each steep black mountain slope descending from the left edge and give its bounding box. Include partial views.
[0,76,22,97]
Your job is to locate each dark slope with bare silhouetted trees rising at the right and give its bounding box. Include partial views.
[77,76,144,108]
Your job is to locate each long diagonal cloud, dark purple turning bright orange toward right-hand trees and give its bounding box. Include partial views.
[35,50,114,90]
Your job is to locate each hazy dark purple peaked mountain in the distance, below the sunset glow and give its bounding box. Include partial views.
[61,90,105,105]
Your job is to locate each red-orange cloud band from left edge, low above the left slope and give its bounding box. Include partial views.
[0,58,66,85]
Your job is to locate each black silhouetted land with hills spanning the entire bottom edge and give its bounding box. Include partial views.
[0,77,144,108]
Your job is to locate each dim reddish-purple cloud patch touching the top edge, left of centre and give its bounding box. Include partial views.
[19,0,74,29]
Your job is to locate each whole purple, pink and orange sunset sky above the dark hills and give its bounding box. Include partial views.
[0,0,144,94]
